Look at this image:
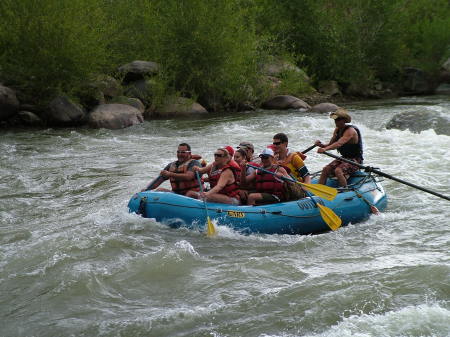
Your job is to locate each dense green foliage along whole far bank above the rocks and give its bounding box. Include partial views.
[0,0,450,106]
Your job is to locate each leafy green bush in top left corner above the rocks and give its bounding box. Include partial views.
[0,0,107,102]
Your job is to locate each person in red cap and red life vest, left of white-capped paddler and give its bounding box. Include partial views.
[187,148,241,205]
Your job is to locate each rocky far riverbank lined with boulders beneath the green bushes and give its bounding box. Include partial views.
[0,59,450,129]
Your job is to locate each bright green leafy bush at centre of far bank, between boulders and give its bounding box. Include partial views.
[145,0,264,105]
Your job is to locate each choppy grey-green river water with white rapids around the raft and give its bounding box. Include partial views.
[0,96,450,337]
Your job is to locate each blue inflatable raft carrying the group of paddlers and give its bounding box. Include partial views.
[128,172,387,234]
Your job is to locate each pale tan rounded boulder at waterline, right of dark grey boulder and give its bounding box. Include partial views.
[88,104,144,129]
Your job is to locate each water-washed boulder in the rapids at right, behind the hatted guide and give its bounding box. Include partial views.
[386,110,450,136]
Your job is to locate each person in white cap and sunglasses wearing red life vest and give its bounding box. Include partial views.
[241,148,290,206]
